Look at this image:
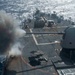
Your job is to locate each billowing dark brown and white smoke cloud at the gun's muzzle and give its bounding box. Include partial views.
[0,11,26,56]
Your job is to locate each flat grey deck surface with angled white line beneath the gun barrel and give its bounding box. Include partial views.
[5,28,73,75]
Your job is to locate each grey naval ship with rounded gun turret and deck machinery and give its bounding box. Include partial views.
[2,10,75,75]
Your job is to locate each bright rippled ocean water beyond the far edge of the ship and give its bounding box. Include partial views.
[0,0,75,20]
